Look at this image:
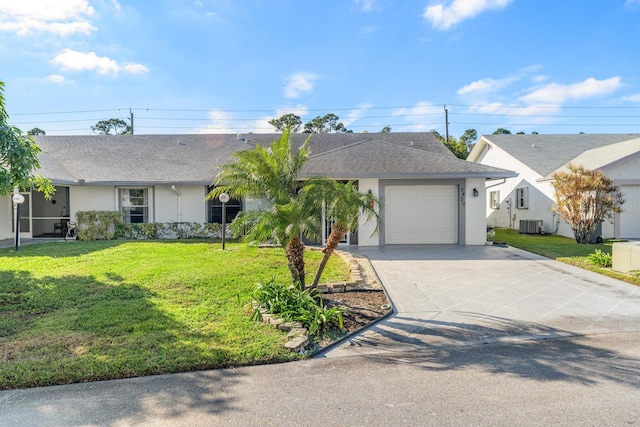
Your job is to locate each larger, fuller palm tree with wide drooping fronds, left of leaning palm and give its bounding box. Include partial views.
[207,130,324,288]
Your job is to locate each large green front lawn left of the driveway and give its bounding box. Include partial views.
[0,241,349,389]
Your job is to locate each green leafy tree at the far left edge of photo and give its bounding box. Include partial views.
[0,81,55,198]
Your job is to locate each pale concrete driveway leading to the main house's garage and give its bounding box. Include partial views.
[320,245,640,357]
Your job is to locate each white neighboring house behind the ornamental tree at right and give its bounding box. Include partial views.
[468,134,640,239]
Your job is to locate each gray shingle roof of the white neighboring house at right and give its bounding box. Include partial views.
[483,134,640,177]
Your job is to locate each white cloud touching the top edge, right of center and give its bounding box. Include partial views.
[422,0,513,30]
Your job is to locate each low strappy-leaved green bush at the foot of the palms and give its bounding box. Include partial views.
[251,278,344,336]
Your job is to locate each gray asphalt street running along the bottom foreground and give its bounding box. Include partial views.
[0,333,640,426]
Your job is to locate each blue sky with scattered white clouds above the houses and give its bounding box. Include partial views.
[0,0,640,136]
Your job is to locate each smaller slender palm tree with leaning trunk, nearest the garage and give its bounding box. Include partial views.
[311,181,381,287]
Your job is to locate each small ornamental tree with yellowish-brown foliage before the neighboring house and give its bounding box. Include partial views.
[552,164,624,243]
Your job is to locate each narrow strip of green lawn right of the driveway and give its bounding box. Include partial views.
[494,228,640,285]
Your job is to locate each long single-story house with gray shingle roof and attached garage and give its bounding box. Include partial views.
[0,133,514,246]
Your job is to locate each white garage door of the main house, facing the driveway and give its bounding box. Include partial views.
[384,185,458,245]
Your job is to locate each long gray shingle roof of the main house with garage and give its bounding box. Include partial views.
[36,133,511,184]
